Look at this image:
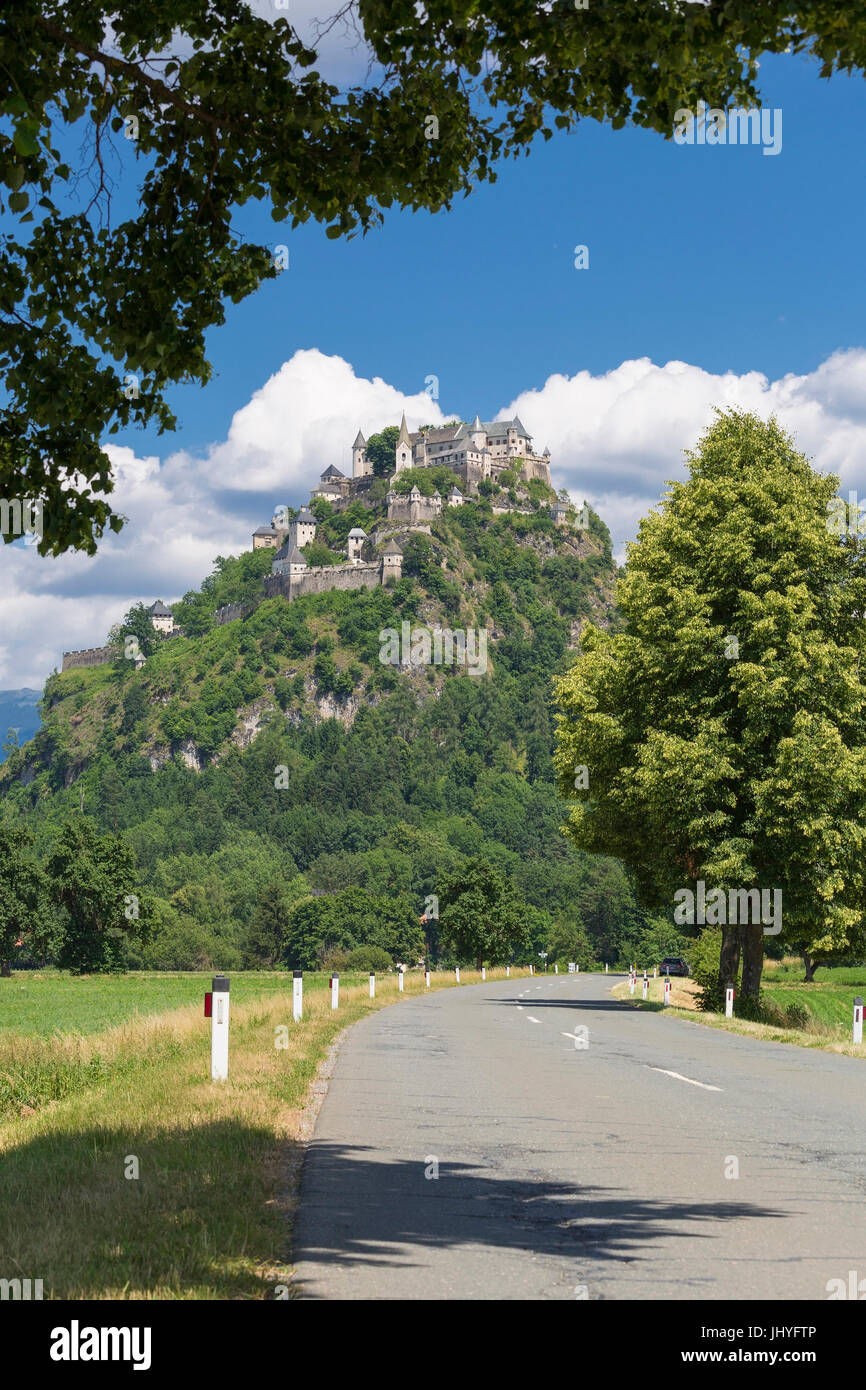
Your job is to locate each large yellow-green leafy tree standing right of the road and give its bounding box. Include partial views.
[555,410,866,995]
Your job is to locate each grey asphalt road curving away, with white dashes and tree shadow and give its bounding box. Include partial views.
[295,974,866,1300]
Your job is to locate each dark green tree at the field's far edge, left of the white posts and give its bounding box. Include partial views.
[46,816,149,974]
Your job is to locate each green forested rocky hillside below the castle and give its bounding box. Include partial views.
[0,500,678,969]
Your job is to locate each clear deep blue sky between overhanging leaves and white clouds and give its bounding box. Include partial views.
[132,57,866,449]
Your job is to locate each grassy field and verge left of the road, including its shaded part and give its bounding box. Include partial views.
[0,970,528,1300]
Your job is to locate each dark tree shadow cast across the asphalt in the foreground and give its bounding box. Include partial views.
[293,1143,790,1298]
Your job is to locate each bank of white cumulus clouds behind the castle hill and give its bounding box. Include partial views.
[0,349,866,689]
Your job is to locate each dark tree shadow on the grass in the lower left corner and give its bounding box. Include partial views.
[0,1119,300,1298]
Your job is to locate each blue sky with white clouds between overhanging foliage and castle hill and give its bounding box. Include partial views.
[0,29,866,689]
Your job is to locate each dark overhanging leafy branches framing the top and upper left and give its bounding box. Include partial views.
[0,0,866,555]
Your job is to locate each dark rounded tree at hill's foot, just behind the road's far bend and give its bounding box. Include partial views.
[439,858,530,969]
